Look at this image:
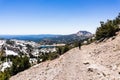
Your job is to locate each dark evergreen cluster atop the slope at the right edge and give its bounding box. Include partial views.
[96,13,120,40]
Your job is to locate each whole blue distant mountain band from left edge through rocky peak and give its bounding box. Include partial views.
[0,31,92,42]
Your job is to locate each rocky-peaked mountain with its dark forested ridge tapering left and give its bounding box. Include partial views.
[41,31,93,44]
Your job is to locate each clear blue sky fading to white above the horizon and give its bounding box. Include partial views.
[0,0,120,35]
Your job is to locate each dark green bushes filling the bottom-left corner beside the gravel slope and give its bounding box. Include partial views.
[0,56,31,80]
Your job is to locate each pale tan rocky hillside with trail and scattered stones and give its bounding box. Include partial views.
[10,33,120,80]
